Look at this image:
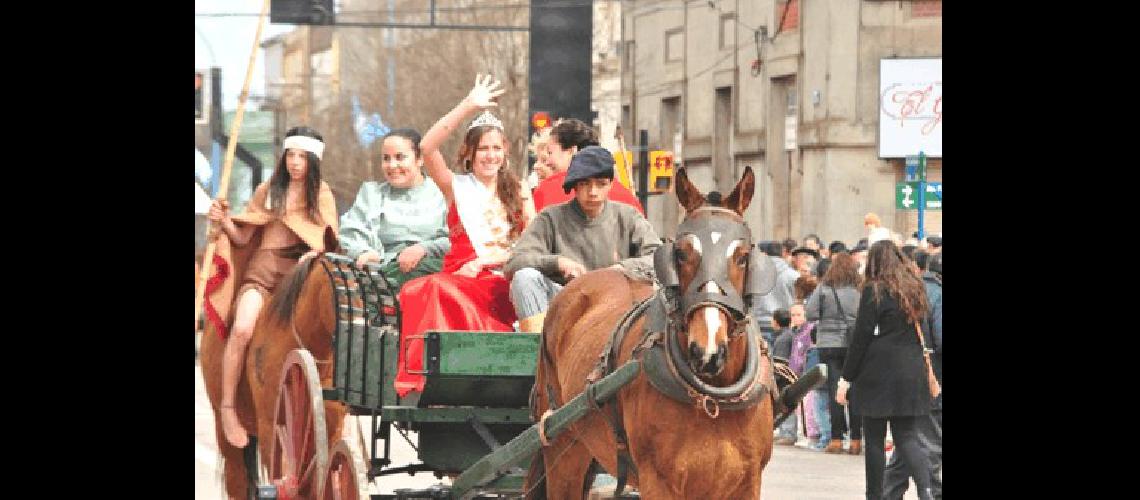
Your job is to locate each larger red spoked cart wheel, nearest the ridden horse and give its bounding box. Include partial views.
[267,349,328,500]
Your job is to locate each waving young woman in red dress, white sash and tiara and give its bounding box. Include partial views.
[396,75,535,397]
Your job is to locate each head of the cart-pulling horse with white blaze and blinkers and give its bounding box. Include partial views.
[654,166,771,385]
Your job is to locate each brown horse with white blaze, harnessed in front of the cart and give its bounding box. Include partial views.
[527,167,773,500]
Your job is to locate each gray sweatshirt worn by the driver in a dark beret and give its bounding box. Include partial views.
[503,199,661,285]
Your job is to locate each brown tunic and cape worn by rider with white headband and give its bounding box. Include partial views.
[205,181,339,338]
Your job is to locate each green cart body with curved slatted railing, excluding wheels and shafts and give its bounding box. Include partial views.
[321,254,538,498]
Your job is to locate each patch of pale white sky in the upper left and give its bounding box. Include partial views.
[194,0,294,110]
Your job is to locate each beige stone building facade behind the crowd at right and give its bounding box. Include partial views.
[620,0,942,245]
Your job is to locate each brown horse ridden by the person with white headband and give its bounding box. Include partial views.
[200,259,347,499]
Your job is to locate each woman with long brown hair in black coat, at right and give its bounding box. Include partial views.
[836,240,933,500]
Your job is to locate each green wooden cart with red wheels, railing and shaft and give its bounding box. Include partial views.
[258,254,638,500]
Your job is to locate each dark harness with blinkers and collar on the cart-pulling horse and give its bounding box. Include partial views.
[530,206,777,494]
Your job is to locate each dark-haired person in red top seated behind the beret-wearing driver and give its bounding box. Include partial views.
[535,118,645,216]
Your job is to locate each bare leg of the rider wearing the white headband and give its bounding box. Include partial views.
[218,288,263,448]
